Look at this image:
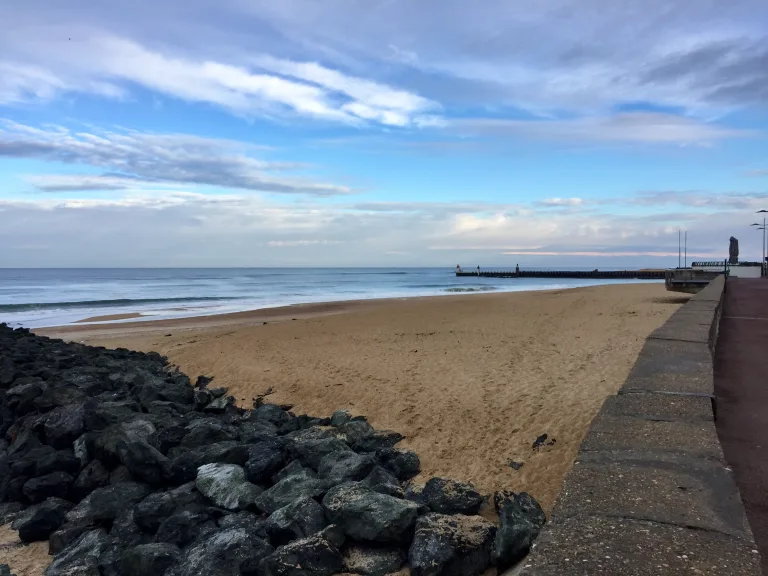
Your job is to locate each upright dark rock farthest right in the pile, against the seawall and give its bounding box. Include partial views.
[491,492,546,570]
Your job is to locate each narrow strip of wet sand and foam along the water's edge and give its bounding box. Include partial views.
[31,281,663,338]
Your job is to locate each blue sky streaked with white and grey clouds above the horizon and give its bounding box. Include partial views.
[0,0,768,267]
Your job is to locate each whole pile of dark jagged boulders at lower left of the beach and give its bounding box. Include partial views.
[0,325,545,576]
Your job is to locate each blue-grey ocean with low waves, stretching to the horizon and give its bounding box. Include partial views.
[0,268,660,328]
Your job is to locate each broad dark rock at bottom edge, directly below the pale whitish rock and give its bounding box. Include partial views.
[167,528,274,576]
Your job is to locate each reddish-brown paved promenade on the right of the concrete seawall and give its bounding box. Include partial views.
[715,278,768,574]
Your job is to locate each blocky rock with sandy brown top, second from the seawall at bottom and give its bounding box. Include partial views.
[408,513,496,576]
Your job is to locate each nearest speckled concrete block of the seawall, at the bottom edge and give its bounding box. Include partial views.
[519,516,761,576]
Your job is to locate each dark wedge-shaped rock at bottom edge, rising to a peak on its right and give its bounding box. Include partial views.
[258,526,343,576]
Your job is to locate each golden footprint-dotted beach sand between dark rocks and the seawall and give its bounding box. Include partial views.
[0,284,684,576]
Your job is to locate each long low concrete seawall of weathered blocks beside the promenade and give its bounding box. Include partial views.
[520,276,761,576]
